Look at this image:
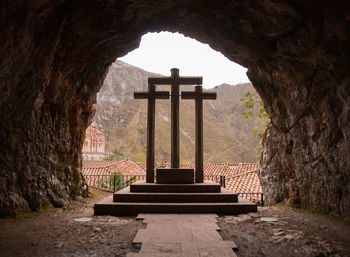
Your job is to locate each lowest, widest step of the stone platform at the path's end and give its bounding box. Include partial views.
[94,196,257,215]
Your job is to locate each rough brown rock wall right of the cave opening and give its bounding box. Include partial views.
[248,4,350,221]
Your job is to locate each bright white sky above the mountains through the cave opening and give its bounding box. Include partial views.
[119,32,249,88]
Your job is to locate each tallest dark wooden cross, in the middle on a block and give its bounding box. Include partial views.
[148,68,203,168]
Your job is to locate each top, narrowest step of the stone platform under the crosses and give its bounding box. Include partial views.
[130,181,221,193]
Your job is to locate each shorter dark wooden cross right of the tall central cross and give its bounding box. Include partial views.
[181,86,216,183]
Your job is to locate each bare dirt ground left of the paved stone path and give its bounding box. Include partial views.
[0,187,144,257]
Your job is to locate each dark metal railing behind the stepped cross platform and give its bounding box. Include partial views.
[84,174,264,206]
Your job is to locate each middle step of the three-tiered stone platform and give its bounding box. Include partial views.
[113,187,238,203]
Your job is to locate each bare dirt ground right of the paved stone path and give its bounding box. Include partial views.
[218,206,350,257]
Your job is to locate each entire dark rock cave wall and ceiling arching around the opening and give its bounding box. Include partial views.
[0,0,350,219]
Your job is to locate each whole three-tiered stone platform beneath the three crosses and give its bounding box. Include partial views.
[94,182,257,215]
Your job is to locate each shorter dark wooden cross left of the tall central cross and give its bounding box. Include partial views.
[134,82,169,183]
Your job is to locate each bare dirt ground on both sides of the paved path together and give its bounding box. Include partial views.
[0,187,350,257]
